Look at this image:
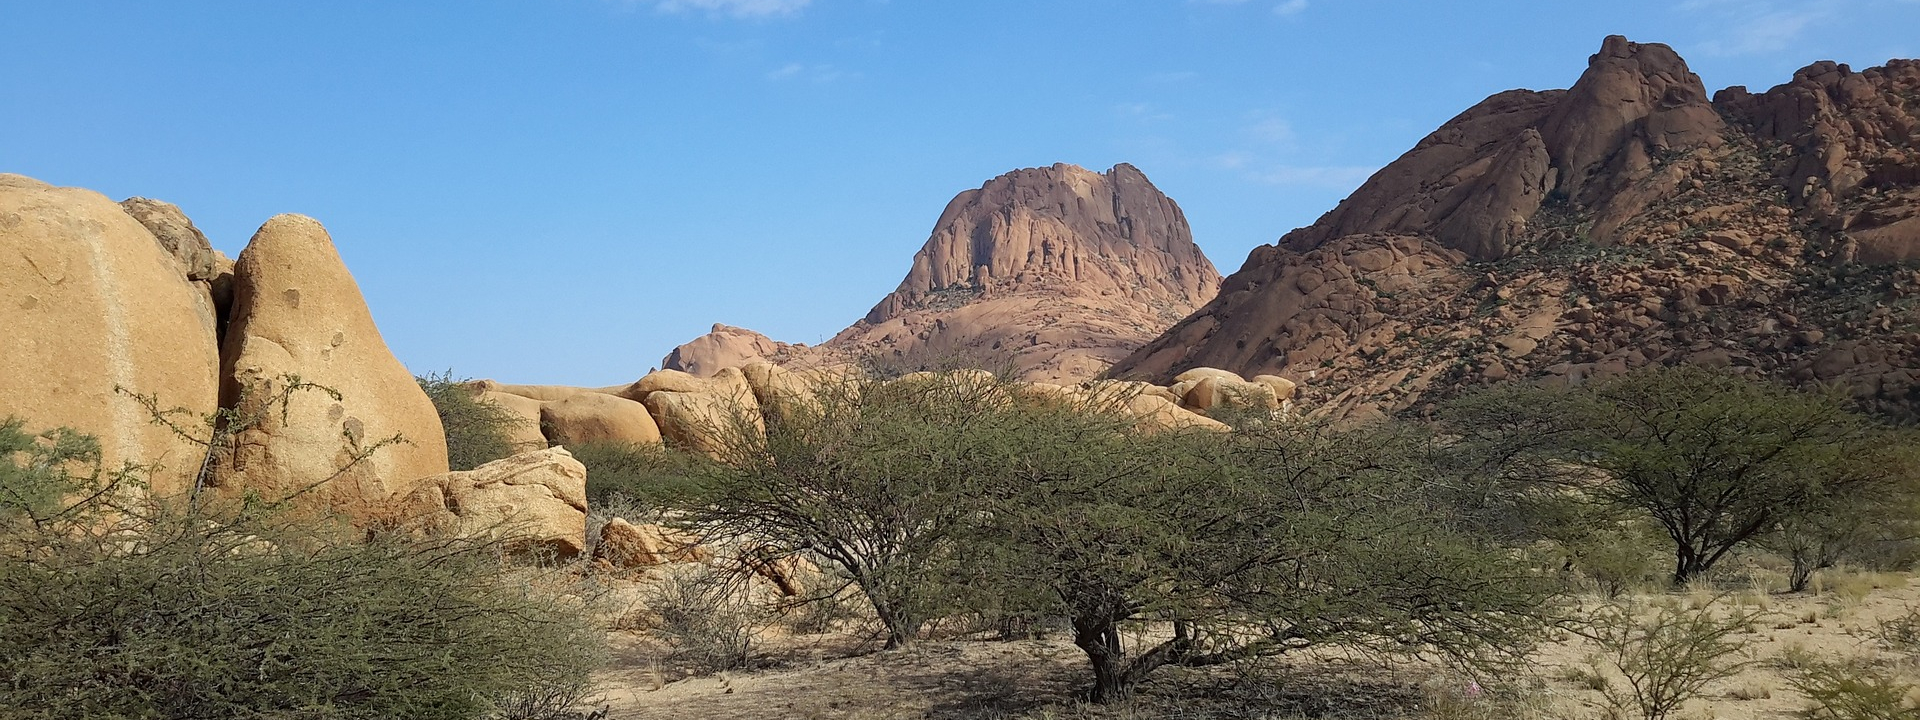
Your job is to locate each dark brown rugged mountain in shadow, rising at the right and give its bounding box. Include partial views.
[1110,36,1920,417]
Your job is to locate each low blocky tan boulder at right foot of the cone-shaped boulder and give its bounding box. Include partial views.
[396,447,588,559]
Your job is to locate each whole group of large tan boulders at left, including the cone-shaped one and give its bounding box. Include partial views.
[0,175,583,555]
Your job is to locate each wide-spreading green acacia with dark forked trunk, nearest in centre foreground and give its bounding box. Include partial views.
[958,405,1549,703]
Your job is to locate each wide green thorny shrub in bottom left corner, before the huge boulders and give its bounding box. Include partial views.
[0,416,603,720]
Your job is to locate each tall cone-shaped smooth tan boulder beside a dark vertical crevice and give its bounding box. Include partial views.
[215,215,447,515]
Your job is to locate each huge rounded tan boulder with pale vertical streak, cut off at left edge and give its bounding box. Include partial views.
[0,175,219,495]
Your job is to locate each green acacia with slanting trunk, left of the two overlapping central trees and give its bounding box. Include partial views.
[660,372,1008,649]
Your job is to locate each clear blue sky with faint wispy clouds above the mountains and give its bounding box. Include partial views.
[0,0,1920,384]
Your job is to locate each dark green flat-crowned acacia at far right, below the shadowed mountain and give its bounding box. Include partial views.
[1450,367,1914,586]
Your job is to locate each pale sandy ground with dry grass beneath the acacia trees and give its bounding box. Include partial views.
[583,574,1920,720]
